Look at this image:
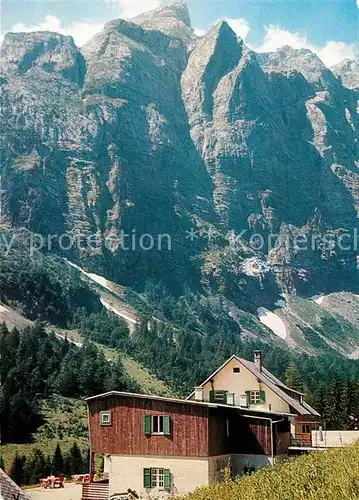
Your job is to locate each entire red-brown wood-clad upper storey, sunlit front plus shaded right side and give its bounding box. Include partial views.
[89,396,290,457]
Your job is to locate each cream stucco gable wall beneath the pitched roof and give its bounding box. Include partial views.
[198,359,290,413]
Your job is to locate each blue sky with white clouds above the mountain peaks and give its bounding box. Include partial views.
[1,0,359,66]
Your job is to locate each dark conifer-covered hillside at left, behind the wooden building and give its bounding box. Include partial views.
[0,325,137,443]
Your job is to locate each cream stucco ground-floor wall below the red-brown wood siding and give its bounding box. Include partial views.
[105,455,209,498]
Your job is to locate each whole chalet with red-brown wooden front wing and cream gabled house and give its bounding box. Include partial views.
[87,352,318,497]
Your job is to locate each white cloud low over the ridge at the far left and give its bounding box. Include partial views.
[10,15,103,47]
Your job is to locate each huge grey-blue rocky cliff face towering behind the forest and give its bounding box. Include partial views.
[0,1,359,310]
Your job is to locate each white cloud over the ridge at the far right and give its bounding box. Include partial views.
[253,24,359,67]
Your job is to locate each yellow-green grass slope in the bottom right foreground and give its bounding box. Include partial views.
[183,444,359,500]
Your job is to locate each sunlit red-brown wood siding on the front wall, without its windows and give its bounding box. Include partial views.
[89,396,208,457]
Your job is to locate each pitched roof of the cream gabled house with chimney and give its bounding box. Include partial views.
[187,354,320,417]
